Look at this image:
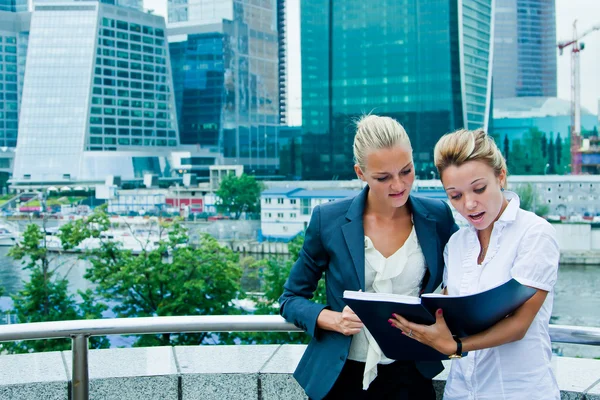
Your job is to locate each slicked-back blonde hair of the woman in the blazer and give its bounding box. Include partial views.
[353,115,411,170]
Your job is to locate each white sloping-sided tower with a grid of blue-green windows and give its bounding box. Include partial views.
[13,2,179,184]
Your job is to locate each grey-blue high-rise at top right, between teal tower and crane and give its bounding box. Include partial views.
[493,0,557,99]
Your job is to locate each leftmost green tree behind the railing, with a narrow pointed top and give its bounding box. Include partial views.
[2,224,110,353]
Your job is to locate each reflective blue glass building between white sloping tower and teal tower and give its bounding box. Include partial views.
[168,0,280,177]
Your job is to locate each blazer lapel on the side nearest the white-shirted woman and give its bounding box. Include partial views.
[408,196,440,292]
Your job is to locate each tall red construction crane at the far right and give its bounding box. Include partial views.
[558,20,600,175]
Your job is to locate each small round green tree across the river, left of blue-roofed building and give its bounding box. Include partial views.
[215,174,262,219]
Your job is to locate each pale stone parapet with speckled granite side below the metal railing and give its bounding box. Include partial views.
[0,345,600,400]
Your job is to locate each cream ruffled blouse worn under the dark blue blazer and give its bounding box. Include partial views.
[348,226,426,389]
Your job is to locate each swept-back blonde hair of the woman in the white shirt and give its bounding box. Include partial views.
[433,129,507,177]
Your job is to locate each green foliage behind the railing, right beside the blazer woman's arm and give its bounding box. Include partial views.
[240,235,327,344]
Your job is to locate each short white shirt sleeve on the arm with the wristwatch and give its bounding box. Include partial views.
[510,221,560,292]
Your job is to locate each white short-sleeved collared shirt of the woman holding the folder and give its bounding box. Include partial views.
[444,192,560,400]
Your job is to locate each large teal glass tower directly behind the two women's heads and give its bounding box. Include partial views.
[300,0,492,179]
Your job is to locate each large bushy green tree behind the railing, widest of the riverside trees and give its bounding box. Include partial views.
[58,211,242,346]
